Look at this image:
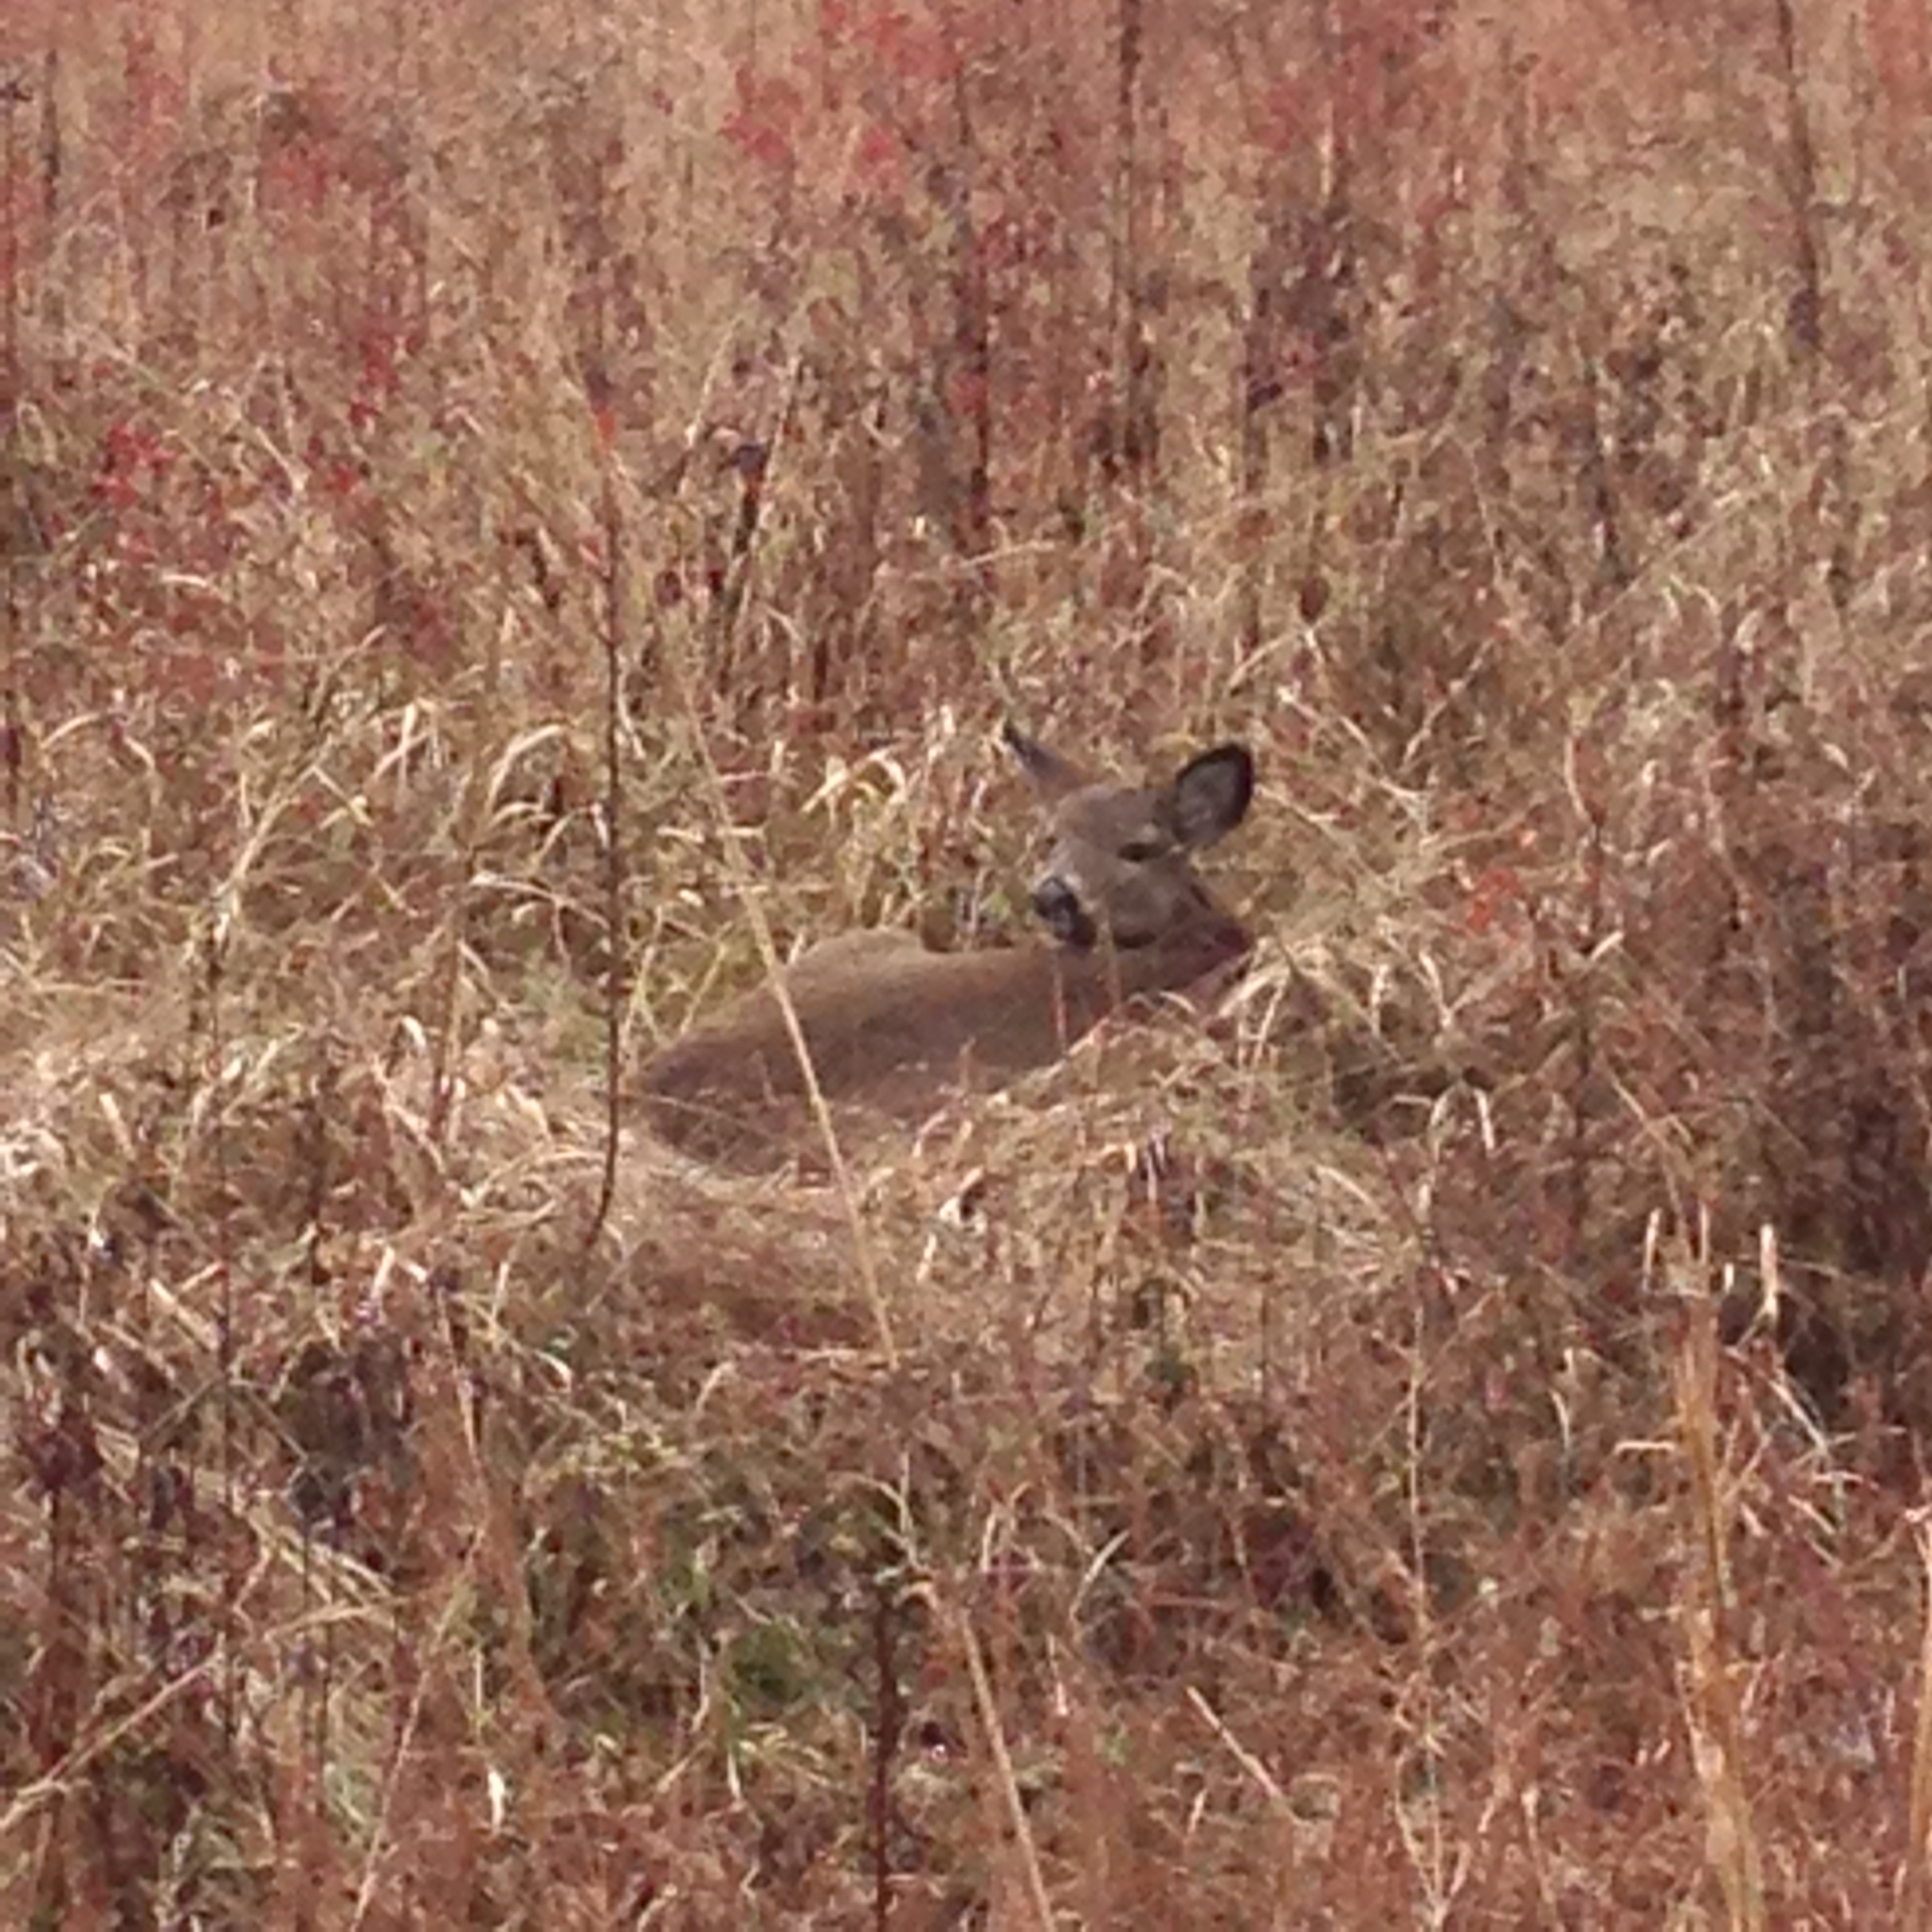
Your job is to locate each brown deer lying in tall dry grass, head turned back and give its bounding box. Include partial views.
[643,721,1254,1169]
